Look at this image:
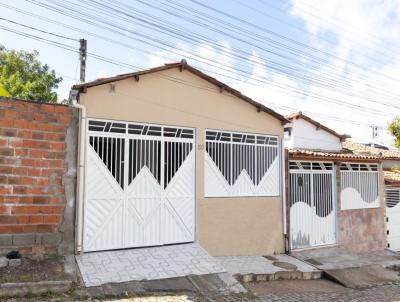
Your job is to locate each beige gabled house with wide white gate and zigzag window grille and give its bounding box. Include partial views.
[71,61,287,255]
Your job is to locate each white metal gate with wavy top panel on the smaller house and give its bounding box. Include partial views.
[289,161,337,249]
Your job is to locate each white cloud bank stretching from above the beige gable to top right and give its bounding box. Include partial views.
[145,0,400,143]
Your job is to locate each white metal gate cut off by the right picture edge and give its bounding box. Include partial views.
[385,187,400,251]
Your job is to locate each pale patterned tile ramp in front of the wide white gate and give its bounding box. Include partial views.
[76,243,226,287]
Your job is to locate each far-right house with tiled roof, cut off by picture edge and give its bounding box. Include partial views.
[343,141,400,251]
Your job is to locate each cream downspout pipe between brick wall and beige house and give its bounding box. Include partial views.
[70,90,86,254]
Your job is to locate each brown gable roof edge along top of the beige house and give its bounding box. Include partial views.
[72,60,289,124]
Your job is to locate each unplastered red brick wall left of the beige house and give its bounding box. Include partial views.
[0,98,77,254]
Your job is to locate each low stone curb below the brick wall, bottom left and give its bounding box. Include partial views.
[0,280,73,297]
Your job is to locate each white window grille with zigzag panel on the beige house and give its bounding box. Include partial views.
[205,130,280,197]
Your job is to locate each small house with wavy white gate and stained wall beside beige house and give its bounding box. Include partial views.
[285,112,386,252]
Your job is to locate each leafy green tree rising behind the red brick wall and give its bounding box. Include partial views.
[0,45,62,103]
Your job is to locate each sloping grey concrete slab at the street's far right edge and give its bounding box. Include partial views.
[324,264,399,288]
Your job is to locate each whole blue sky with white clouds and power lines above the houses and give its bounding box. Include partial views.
[0,0,400,144]
